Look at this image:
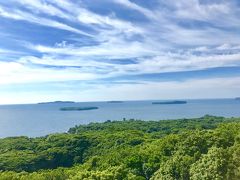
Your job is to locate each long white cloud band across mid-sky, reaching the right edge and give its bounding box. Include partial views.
[21,44,240,76]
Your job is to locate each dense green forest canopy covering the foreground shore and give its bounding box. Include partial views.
[0,115,240,180]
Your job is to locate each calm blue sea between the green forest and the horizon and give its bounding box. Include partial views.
[0,99,240,137]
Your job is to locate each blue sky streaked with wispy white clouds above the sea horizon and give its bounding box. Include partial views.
[0,0,240,104]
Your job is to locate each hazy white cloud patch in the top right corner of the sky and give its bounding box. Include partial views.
[158,0,240,27]
